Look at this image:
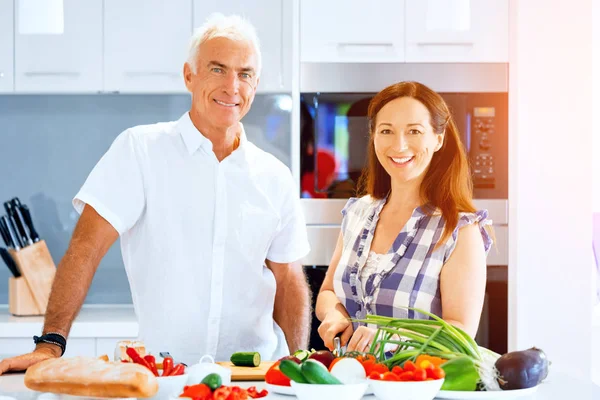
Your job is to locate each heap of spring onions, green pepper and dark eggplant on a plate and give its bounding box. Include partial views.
[360,309,549,391]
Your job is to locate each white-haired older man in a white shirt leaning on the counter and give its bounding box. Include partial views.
[0,15,310,373]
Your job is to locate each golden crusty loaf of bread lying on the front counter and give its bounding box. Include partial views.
[25,357,158,398]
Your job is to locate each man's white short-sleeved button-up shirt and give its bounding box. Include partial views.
[73,113,309,365]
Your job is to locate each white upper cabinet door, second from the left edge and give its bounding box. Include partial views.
[15,0,102,93]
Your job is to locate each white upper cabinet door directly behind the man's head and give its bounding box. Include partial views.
[194,0,292,93]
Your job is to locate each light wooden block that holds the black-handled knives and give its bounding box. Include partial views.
[8,240,56,316]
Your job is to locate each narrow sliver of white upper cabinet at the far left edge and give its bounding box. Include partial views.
[0,0,15,93]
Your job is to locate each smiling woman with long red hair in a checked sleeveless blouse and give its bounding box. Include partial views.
[316,82,492,352]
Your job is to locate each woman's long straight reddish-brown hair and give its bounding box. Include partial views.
[359,82,475,247]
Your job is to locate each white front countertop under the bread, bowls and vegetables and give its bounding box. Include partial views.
[0,372,600,400]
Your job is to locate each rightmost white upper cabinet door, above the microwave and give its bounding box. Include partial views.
[406,0,509,62]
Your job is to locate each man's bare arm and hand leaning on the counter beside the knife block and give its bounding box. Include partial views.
[0,205,119,375]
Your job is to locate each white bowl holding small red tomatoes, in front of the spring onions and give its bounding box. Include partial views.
[369,379,444,400]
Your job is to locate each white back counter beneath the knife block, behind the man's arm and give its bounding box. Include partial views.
[0,305,138,338]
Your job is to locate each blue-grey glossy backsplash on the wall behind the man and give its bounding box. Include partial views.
[0,94,291,304]
